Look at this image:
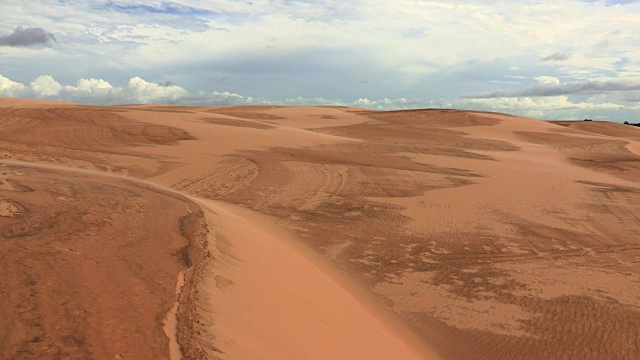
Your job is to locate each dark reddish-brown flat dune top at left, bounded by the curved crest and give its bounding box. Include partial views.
[0,164,197,359]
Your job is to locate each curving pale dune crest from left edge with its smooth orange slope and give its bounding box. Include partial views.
[2,160,437,360]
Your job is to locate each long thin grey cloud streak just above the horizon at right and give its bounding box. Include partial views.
[464,78,640,99]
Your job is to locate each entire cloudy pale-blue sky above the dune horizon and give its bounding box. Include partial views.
[0,0,640,122]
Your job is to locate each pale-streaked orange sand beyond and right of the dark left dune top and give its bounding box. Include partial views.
[0,100,640,360]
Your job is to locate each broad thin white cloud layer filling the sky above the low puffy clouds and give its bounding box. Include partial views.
[0,0,640,109]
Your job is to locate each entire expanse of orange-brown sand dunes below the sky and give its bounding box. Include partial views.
[0,99,640,360]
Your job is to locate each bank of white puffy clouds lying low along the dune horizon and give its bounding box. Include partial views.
[0,75,640,121]
